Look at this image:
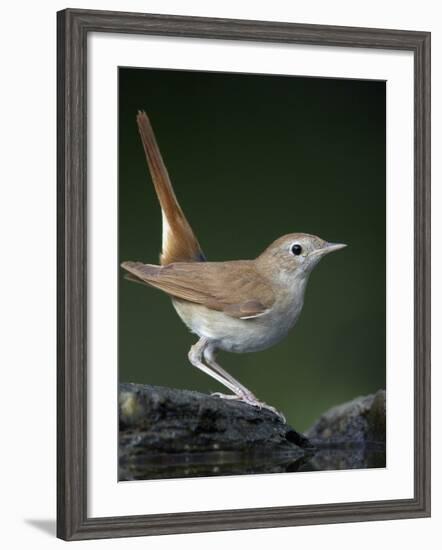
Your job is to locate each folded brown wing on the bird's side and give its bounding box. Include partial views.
[121,261,275,319]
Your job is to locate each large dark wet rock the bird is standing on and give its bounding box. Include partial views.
[119,384,309,480]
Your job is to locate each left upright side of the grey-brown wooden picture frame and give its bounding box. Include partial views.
[57,7,87,539]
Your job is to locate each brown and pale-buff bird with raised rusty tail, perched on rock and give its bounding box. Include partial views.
[121,111,346,422]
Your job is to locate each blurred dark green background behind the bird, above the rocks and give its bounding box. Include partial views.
[119,68,386,430]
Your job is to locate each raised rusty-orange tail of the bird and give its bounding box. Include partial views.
[137,111,205,265]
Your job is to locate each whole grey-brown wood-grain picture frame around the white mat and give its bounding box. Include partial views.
[57,10,430,540]
